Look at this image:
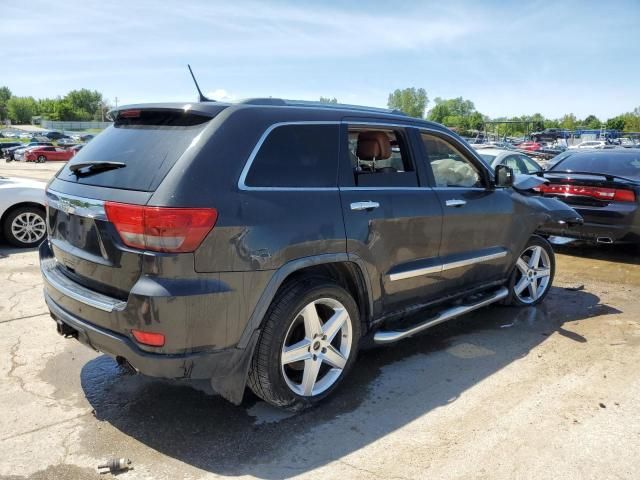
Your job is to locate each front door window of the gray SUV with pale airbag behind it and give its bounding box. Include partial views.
[421,133,484,187]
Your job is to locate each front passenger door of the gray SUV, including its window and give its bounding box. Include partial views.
[420,131,526,290]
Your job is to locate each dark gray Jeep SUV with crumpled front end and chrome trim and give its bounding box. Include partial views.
[40,99,579,409]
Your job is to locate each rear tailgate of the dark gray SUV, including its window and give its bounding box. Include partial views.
[47,108,222,301]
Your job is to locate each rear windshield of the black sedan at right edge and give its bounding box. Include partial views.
[551,151,640,178]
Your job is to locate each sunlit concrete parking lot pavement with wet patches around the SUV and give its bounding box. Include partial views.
[0,162,640,479]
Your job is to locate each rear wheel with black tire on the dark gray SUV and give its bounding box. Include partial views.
[248,278,360,410]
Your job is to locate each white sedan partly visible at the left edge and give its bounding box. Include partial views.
[0,177,47,247]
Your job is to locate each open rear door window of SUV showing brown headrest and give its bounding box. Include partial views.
[348,127,418,187]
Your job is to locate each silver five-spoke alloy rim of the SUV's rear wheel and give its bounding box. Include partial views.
[280,298,353,397]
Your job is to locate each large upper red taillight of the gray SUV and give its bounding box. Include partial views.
[104,202,218,253]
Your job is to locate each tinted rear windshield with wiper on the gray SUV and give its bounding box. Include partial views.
[58,111,211,191]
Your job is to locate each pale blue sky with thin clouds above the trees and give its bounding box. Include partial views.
[0,0,640,118]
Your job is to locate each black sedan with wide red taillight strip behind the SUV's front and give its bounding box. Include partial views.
[537,149,640,243]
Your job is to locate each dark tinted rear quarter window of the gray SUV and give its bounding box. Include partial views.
[245,125,340,188]
